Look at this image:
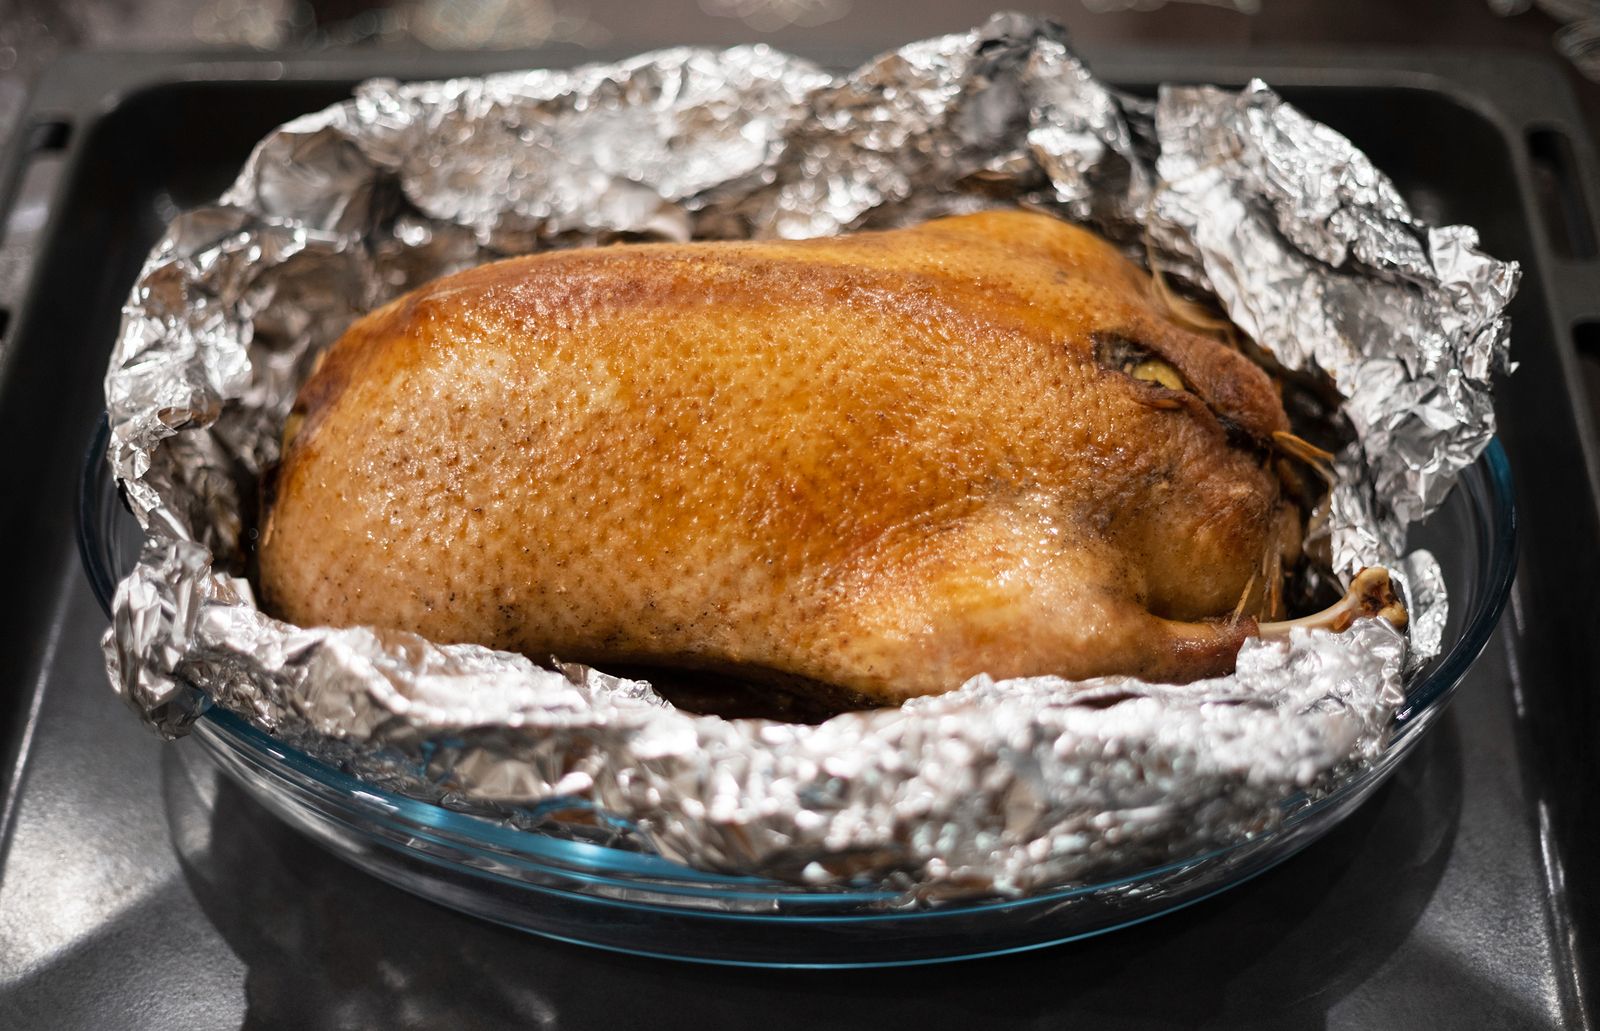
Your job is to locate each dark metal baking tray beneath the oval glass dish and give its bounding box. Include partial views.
[0,51,1600,1028]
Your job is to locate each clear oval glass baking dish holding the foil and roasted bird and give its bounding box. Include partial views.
[78,419,1517,967]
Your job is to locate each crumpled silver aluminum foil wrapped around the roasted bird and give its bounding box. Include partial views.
[104,14,1517,897]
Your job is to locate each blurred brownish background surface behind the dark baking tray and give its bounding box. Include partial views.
[0,0,1600,334]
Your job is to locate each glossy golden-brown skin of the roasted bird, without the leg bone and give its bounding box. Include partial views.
[259,211,1294,703]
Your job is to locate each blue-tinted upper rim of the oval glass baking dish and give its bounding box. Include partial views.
[77,416,1517,921]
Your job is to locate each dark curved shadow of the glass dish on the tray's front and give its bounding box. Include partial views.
[163,714,1478,1031]
